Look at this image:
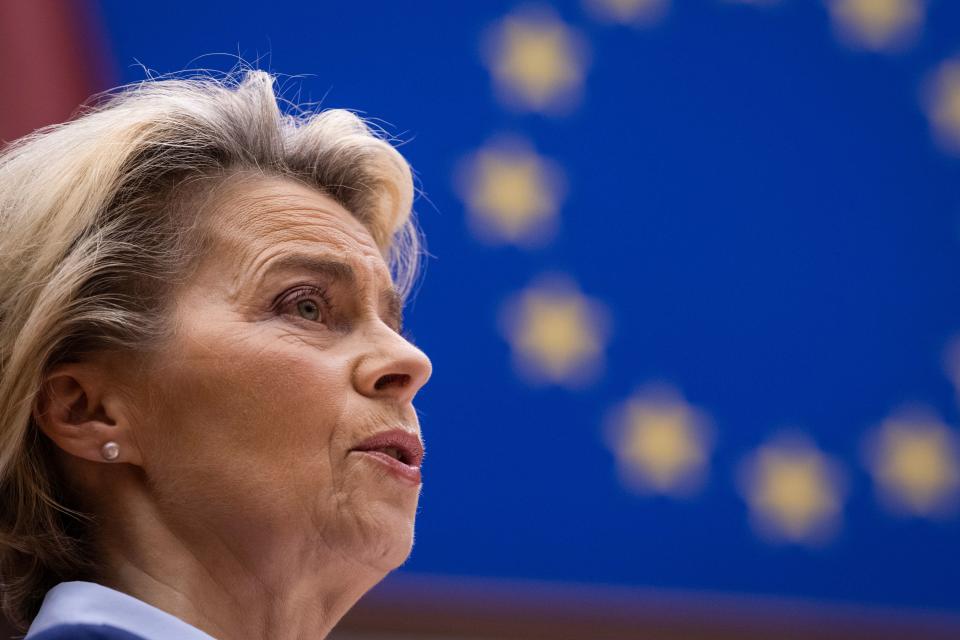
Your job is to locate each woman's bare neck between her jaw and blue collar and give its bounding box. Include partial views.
[89,476,385,640]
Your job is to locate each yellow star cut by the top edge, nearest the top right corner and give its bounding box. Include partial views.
[827,0,924,51]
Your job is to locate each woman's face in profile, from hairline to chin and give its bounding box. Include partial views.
[126,178,431,571]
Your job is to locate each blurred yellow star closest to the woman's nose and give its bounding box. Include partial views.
[500,276,608,387]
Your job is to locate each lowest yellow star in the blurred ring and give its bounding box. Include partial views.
[741,436,842,543]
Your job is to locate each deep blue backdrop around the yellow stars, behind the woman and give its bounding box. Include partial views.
[100,0,960,612]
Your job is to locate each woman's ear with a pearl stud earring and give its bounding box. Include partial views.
[33,362,143,466]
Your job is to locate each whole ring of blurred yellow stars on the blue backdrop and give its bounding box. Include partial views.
[455,0,960,545]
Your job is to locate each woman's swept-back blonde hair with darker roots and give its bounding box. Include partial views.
[0,70,421,629]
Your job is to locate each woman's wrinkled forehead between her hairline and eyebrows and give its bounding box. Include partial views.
[197,176,393,292]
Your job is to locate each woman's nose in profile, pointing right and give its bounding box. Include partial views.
[353,323,433,404]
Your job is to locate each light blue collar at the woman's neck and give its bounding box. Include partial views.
[26,580,215,640]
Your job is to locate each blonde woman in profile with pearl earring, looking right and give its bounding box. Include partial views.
[0,71,431,640]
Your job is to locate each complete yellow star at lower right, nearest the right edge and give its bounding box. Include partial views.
[866,412,960,517]
